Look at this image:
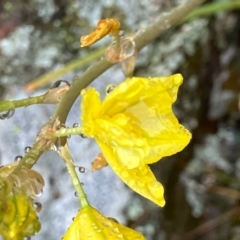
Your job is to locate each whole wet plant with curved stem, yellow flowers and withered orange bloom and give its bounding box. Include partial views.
[0,0,206,240]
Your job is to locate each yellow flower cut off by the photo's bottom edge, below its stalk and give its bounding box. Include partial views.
[63,206,145,240]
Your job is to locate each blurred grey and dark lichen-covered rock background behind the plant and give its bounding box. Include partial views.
[0,0,240,240]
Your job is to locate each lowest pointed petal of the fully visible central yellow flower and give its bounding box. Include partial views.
[97,141,165,207]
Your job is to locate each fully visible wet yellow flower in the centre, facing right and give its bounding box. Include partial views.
[81,74,191,206]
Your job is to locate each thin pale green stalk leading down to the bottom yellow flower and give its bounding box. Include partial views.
[57,144,90,208]
